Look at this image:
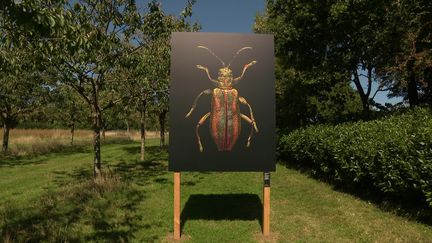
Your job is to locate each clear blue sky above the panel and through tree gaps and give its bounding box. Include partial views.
[137,0,402,104]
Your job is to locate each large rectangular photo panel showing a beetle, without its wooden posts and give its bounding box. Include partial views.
[169,32,276,171]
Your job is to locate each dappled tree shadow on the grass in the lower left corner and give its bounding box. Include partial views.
[0,175,146,242]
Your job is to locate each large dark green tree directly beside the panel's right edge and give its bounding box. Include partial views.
[254,0,379,129]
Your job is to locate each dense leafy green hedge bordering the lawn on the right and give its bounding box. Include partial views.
[278,109,432,207]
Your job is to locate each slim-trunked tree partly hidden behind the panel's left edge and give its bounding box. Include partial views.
[119,1,199,160]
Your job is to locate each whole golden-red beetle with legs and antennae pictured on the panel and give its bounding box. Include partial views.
[186,46,258,152]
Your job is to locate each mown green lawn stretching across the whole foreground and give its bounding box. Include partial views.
[0,140,432,242]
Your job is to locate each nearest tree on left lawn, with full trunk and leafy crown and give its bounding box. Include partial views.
[47,0,141,177]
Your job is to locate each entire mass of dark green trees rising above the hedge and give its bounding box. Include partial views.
[254,0,432,120]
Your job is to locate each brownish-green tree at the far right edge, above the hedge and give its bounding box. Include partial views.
[378,1,432,107]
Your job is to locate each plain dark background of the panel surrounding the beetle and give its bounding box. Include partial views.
[169,32,276,171]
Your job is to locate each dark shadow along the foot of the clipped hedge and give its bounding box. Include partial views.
[278,161,432,225]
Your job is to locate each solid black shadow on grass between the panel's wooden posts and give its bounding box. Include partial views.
[180,193,263,233]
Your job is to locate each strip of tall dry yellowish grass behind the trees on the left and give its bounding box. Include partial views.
[0,129,162,155]
